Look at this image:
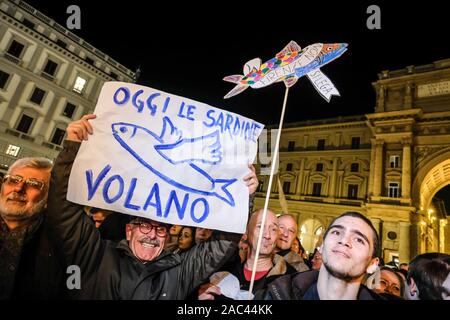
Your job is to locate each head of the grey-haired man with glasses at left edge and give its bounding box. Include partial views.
[0,157,53,229]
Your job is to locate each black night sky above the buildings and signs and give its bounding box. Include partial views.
[22,0,450,125]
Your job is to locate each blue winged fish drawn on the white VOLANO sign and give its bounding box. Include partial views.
[111,117,237,207]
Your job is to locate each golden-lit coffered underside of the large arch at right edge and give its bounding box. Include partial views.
[412,148,450,210]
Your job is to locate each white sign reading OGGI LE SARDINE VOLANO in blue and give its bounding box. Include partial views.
[67,82,263,233]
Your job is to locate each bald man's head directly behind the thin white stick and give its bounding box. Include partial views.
[247,209,278,258]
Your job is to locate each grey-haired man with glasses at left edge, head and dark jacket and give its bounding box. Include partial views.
[0,158,65,299]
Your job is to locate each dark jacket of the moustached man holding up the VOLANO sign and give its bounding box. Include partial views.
[47,141,241,299]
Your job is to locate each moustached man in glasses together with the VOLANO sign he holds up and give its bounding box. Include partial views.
[48,82,263,299]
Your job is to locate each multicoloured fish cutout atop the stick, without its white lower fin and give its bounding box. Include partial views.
[223,41,347,99]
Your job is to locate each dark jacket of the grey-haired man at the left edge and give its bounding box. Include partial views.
[0,214,66,300]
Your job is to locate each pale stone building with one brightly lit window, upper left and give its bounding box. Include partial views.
[0,0,135,173]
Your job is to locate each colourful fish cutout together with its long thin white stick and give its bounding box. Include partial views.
[224,41,347,294]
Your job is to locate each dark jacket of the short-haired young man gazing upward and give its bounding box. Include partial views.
[265,270,383,300]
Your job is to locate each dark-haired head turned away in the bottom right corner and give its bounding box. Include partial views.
[404,253,450,300]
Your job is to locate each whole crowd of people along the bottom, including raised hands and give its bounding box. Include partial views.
[0,115,450,300]
